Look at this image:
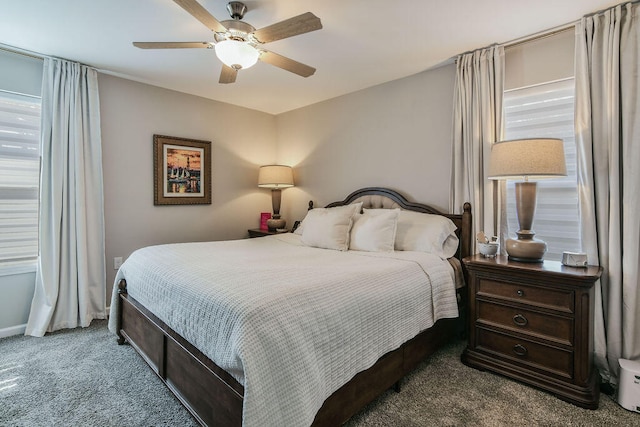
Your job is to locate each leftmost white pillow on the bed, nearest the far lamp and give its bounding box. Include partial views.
[300,203,362,251]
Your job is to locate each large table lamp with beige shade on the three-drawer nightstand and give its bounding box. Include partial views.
[488,138,567,262]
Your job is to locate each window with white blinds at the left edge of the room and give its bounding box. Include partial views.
[0,91,40,274]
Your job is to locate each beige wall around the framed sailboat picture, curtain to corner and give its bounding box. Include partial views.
[98,74,276,301]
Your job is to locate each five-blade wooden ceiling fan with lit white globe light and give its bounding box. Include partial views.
[133,0,322,83]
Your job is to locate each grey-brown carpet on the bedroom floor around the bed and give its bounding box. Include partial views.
[0,321,640,427]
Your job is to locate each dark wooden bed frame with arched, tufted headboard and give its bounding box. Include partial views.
[117,187,472,426]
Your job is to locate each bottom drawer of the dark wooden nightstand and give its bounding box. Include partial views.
[476,328,573,379]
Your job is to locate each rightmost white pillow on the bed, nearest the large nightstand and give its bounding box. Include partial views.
[395,211,458,258]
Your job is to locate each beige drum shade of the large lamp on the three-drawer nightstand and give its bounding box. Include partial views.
[489,138,567,179]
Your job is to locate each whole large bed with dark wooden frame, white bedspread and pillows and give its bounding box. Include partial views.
[109,188,471,427]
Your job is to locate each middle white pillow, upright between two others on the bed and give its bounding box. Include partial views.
[349,209,400,252]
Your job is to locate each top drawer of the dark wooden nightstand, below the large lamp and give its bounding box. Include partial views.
[478,279,574,313]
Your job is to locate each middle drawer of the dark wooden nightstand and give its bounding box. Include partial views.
[477,301,573,345]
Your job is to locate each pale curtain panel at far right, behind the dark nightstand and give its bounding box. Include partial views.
[575,3,640,383]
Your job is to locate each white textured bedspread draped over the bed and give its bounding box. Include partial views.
[109,234,458,427]
